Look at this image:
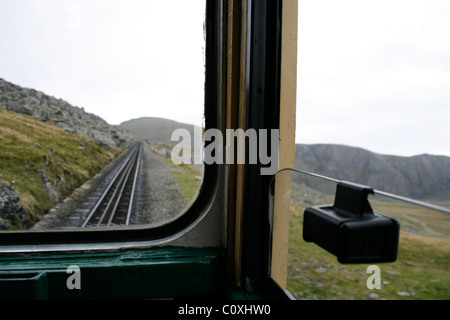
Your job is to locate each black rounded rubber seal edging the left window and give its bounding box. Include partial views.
[0,0,223,252]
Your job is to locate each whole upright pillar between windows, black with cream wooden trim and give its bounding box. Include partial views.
[223,0,297,299]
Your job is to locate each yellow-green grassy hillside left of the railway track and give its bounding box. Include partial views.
[0,108,119,228]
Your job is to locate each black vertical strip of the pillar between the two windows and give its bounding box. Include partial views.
[240,0,291,300]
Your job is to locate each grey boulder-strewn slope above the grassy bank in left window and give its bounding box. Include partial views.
[0,78,133,149]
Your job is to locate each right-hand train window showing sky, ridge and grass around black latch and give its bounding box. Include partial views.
[284,1,450,299]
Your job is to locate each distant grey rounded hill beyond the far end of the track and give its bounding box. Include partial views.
[119,117,203,144]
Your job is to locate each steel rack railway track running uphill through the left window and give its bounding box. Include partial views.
[81,143,142,228]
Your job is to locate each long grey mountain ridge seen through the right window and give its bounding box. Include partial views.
[295,144,450,201]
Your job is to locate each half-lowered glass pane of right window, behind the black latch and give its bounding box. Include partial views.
[277,171,450,300]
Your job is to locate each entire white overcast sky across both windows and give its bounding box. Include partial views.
[0,0,450,156]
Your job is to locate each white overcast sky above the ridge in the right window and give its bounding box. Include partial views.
[296,0,450,156]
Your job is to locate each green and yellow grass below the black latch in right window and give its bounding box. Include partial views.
[287,200,450,300]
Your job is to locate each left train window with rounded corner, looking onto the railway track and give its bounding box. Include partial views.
[0,0,217,239]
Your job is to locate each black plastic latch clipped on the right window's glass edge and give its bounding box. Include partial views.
[303,181,400,264]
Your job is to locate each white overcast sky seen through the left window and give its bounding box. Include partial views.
[0,0,205,125]
